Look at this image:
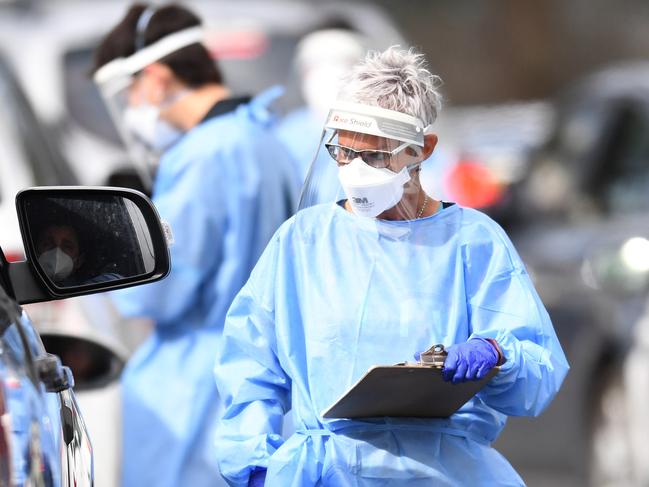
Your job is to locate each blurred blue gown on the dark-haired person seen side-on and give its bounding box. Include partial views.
[115,91,298,487]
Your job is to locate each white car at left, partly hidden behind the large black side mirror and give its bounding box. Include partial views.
[0,51,148,485]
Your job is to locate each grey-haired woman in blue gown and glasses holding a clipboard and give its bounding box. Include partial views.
[215,47,568,487]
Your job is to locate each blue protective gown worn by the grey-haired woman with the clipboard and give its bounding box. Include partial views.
[215,204,568,487]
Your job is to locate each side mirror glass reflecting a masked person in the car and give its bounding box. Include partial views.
[24,193,155,288]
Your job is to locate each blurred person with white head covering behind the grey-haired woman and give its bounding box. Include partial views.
[277,21,365,193]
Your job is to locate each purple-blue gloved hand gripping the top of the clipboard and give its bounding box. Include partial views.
[442,338,500,384]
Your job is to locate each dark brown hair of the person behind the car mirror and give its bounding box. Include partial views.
[93,3,223,88]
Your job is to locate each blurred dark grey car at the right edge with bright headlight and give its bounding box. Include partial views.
[488,63,649,485]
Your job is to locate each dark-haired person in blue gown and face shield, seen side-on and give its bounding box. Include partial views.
[94,4,297,487]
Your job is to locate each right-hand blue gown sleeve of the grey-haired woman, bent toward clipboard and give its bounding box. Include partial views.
[465,224,569,416]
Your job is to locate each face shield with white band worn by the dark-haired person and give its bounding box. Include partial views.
[94,27,203,188]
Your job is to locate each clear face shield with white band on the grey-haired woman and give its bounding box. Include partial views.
[300,103,433,221]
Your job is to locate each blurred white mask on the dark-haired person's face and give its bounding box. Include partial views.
[124,104,182,152]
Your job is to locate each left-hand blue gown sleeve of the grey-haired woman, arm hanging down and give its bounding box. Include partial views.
[215,235,290,486]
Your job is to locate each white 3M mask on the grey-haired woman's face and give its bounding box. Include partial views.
[338,157,410,218]
